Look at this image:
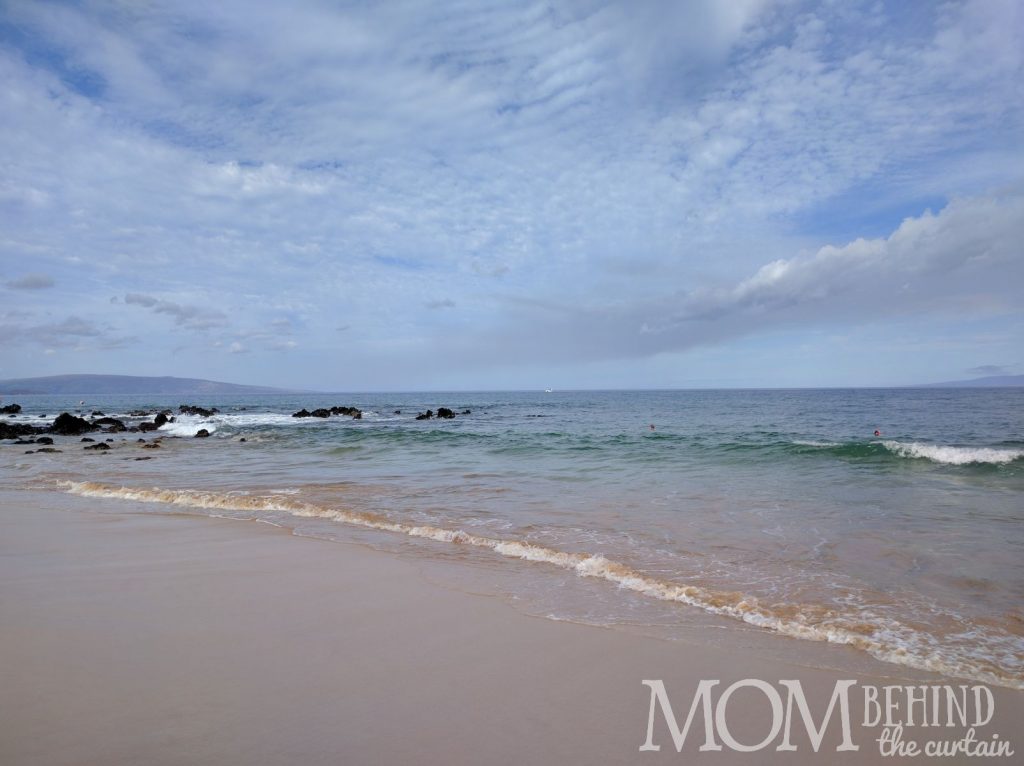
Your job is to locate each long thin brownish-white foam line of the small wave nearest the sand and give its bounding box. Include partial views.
[58,481,1024,689]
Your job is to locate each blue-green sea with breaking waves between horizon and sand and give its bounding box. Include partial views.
[0,389,1024,688]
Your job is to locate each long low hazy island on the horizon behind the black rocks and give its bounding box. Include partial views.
[0,375,300,395]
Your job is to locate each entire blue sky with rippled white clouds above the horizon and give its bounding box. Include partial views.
[0,0,1024,390]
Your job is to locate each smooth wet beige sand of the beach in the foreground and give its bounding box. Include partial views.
[0,492,1024,766]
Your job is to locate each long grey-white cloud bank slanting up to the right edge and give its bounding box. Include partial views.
[450,194,1024,363]
